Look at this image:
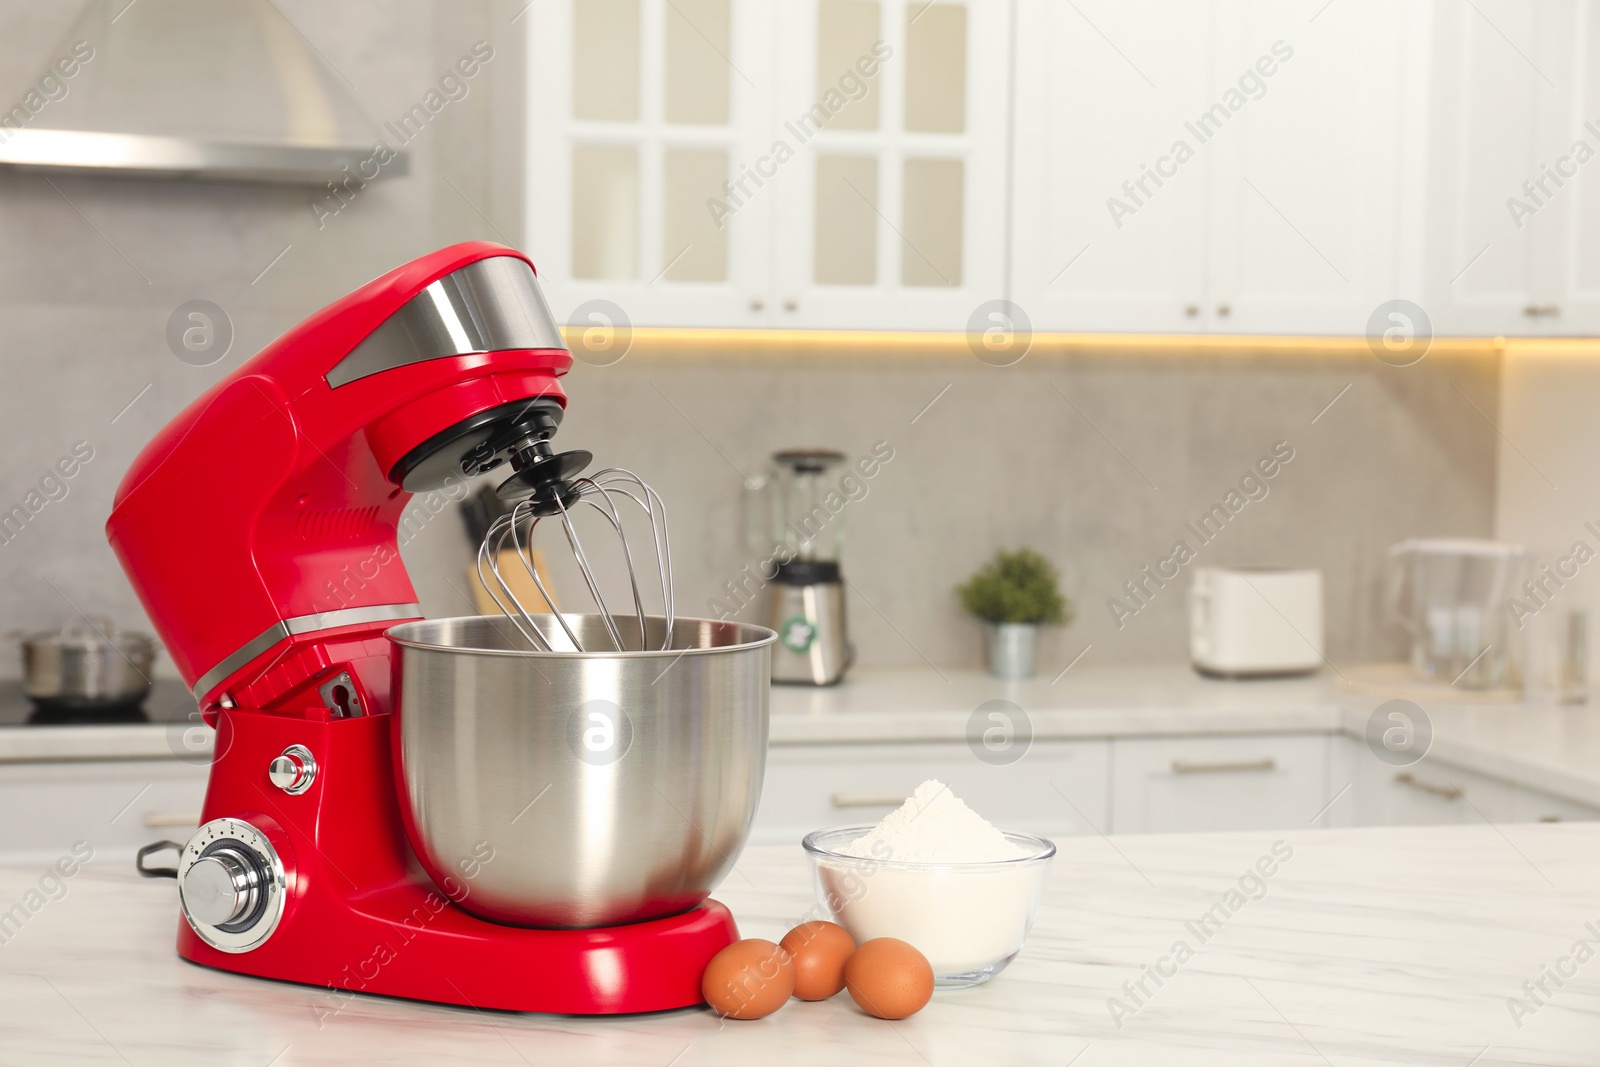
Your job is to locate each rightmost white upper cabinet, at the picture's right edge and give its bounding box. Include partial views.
[1424,0,1600,334]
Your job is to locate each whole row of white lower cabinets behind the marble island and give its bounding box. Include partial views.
[0,734,1600,865]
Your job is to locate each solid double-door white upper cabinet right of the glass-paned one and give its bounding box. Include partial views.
[1013,0,1426,334]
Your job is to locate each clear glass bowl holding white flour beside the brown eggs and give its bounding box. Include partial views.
[800,825,1056,989]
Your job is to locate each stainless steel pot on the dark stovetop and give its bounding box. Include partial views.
[22,622,157,709]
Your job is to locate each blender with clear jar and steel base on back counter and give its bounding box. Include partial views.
[760,448,854,685]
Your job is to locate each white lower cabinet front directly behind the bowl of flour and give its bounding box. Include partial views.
[750,741,1110,845]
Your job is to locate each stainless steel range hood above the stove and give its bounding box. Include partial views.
[0,0,408,184]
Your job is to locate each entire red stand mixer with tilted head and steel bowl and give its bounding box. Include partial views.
[106,243,770,1014]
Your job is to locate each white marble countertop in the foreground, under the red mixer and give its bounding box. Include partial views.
[0,824,1600,1067]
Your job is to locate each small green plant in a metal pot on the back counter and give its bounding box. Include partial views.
[955,549,1074,678]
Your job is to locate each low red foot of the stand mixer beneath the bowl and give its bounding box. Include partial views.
[178,881,739,1025]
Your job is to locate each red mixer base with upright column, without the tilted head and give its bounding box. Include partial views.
[178,709,739,1019]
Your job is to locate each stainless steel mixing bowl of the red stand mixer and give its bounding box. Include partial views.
[387,616,776,927]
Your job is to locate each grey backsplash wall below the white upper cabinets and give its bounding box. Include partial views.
[531,342,1499,670]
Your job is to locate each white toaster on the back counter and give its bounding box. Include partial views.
[1189,566,1322,678]
